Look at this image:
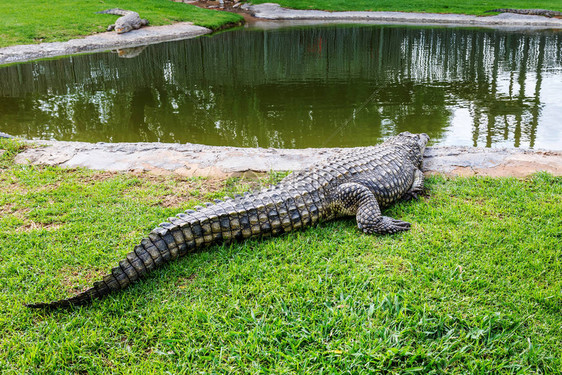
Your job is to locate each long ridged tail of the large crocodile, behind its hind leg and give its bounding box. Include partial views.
[26,187,321,309]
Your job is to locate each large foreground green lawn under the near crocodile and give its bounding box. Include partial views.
[0,141,562,374]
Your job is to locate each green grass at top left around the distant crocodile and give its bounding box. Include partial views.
[0,0,242,47]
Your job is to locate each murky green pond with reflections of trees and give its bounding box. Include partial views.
[0,25,562,149]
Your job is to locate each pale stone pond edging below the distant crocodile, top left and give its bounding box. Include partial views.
[0,22,212,65]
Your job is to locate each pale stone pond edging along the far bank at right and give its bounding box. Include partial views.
[242,3,562,28]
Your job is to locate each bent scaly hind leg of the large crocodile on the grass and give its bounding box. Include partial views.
[338,183,410,234]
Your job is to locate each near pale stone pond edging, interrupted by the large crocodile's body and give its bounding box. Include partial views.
[16,141,562,177]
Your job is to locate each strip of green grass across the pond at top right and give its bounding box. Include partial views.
[251,0,562,15]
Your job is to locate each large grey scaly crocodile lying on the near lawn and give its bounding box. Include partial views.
[27,132,429,309]
